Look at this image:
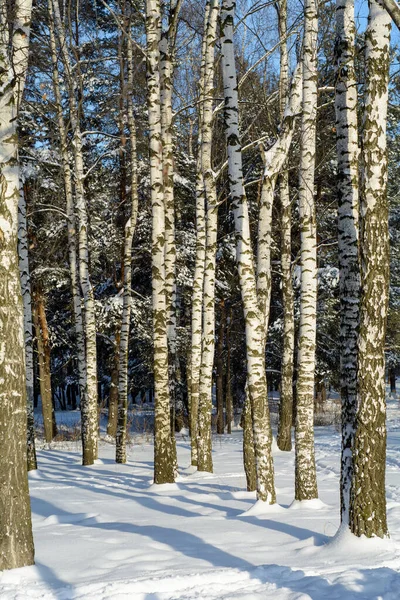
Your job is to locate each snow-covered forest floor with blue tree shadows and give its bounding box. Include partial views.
[0,401,400,600]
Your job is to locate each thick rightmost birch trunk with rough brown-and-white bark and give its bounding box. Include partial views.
[350,0,391,537]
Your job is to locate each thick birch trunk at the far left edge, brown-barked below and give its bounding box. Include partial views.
[0,0,34,571]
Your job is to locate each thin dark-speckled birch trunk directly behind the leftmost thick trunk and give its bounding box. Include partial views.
[18,187,37,471]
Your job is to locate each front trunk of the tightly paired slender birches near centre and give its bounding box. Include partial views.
[197,0,219,472]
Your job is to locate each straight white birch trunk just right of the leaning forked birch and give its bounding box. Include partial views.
[295,0,318,500]
